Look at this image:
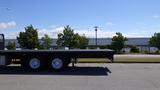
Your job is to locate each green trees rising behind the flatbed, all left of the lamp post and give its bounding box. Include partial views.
[6,25,88,50]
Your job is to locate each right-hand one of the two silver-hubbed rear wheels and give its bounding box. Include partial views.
[50,58,64,71]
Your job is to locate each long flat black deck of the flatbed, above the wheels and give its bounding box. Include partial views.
[0,49,113,60]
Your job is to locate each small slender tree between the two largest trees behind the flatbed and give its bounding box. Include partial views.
[42,34,52,49]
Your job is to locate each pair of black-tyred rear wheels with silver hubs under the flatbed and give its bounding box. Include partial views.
[22,57,70,71]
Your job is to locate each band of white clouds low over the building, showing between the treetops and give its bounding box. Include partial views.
[4,26,152,39]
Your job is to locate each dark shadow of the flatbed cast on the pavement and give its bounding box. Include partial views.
[0,66,112,76]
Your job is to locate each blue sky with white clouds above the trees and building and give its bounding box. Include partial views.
[0,0,160,39]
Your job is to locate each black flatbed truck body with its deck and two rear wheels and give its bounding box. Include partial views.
[0,34,114,71]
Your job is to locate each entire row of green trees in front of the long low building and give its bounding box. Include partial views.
[6,25,160,53]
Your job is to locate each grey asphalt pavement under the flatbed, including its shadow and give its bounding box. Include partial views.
[0,63,160,90]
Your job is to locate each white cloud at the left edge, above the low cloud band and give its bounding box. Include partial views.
[0,21,16,30]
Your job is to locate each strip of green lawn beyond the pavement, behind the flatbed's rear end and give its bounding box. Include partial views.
[79,57,160,63]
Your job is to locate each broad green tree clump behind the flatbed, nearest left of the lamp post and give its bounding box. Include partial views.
[57,25,88,48]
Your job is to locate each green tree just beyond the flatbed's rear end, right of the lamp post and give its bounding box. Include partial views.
[111,32,127,53]
